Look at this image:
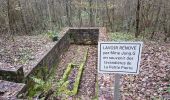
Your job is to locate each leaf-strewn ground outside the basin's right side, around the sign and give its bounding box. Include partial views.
[98,33,170,100]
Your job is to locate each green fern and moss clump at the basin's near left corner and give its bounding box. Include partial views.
[26,66,55,100]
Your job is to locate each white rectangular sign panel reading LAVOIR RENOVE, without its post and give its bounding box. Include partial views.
[98,42,143,74]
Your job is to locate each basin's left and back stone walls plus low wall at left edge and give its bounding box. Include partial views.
[0,27,108,98]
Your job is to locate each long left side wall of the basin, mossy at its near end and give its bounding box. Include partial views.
[25,28,70,80]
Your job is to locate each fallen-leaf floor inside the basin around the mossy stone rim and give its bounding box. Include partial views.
[56,45,97,99]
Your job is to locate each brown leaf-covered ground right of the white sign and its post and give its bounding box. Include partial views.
[121,41,170,100]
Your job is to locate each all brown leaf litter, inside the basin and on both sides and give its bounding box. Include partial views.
[0,32,170,100]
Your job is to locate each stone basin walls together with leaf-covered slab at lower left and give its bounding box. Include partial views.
[0,27,108,99]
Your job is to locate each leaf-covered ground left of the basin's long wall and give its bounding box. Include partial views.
[0,35,54,74]
